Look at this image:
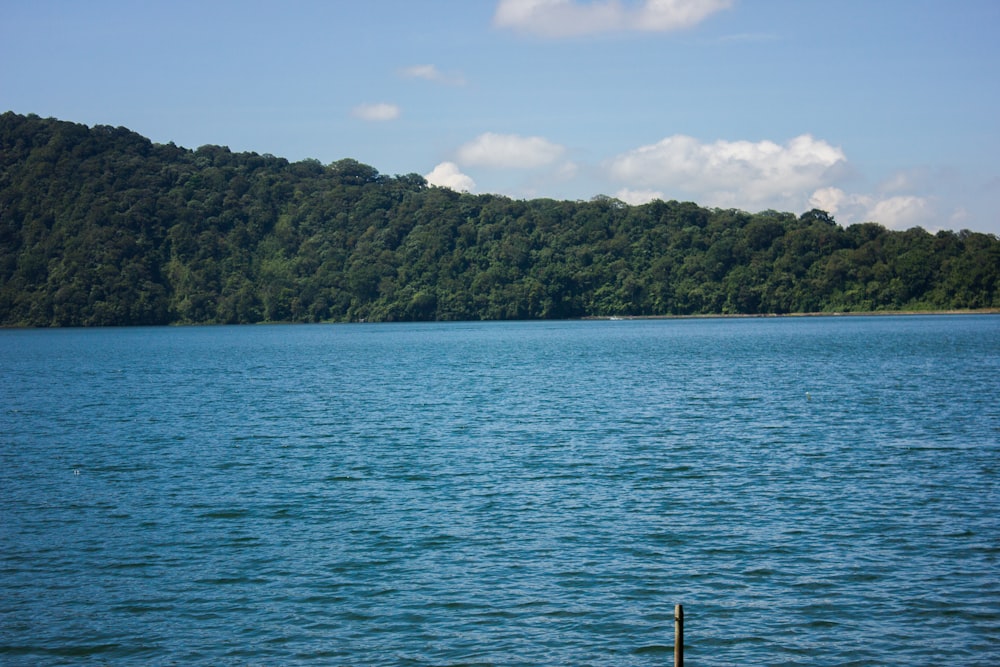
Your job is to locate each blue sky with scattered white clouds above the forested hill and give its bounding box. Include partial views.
[0,0,1000,235]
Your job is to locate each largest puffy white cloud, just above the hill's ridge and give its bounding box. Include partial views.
[610,134,847,210]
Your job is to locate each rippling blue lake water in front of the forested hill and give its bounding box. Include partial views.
[0,316,1000,666]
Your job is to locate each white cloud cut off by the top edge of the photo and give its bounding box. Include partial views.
[493,0,733,37]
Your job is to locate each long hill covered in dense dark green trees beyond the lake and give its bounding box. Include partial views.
[0,112,1000,326]
